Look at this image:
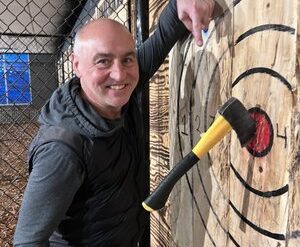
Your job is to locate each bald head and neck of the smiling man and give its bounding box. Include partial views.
[72,19,139,119]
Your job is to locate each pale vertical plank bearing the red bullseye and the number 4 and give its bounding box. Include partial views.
[230,0,297,246]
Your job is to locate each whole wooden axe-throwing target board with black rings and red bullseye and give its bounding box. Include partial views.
[168,0,300,247]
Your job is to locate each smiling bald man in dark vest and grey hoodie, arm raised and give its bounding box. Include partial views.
[14,0,211,247]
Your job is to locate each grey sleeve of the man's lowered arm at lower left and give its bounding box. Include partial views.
[14,142,84,247]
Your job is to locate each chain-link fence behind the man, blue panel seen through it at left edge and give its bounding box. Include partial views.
[0,0,135,243]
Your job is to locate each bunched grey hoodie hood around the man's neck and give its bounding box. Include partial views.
[39,77,126,137]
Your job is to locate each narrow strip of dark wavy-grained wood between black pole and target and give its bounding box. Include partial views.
[149,0,171,247]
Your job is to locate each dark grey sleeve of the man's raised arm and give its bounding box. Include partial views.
[138,0,188,85]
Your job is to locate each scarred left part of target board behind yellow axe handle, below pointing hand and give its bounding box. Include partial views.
[170,1,233,246]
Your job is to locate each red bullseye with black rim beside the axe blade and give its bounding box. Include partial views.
[246,107,274,157]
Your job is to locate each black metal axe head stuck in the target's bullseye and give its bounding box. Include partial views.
[219,97,256,147]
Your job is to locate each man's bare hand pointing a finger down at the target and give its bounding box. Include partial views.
[177,0,215,46]
